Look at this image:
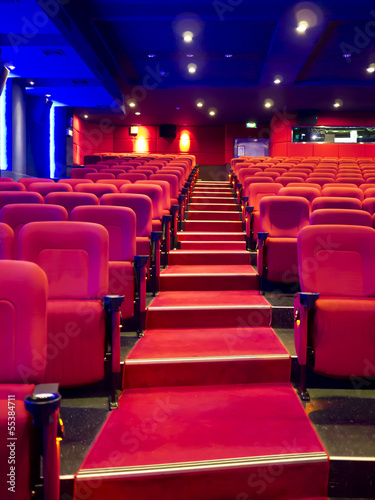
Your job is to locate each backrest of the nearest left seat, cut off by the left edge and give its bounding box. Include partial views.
[0,260,48,384]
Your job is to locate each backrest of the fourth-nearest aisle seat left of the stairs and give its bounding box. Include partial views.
[100,193,152,238]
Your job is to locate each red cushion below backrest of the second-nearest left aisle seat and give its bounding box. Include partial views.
[45,299,105,387]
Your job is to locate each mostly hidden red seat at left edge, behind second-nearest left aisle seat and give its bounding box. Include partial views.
[0,203,68,260]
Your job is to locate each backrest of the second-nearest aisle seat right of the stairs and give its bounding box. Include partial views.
[259,196,310,238]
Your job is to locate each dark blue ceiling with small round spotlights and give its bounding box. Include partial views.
[0,0,375,124]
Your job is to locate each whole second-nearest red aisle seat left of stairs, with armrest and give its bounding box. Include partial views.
[19,222,121,387]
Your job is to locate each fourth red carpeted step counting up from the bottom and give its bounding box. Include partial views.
[160,265,258,291]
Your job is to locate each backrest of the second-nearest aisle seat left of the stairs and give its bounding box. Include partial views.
[19,222,109,300]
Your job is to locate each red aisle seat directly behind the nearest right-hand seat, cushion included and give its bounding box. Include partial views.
[257,196,310,289]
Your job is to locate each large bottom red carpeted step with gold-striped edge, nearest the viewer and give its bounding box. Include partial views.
[74,383,329,500]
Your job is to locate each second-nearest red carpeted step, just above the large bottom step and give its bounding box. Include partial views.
[123,327,291,389]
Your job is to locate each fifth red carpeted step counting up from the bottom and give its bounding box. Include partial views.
[168,250,251,266]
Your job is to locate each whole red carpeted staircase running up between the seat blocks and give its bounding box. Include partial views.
[75,181,329,500]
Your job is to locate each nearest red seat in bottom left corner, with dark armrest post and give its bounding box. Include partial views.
[0,260,61,500]
